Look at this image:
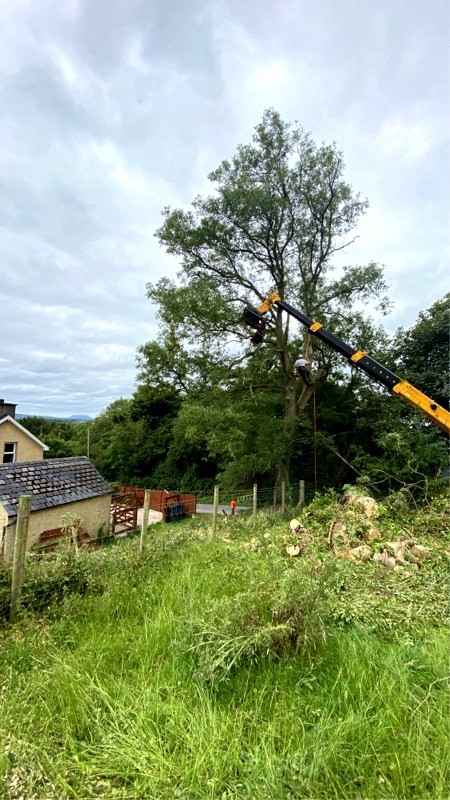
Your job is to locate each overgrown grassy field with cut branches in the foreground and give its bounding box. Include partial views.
[0,495,450,800]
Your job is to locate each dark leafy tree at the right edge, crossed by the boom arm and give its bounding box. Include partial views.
[338,295,450,490]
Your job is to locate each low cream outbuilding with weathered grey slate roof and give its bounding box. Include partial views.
[0,456,112,560]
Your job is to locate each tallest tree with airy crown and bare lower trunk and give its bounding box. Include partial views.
[145,110,387,490]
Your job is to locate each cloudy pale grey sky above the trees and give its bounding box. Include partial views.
[0,0,450,417]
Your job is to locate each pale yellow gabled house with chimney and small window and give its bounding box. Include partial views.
[0,399,48,464]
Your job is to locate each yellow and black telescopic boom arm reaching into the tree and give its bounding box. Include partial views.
[244,292,450,434]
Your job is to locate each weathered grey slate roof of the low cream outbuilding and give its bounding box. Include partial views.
[0,456,112,517]
